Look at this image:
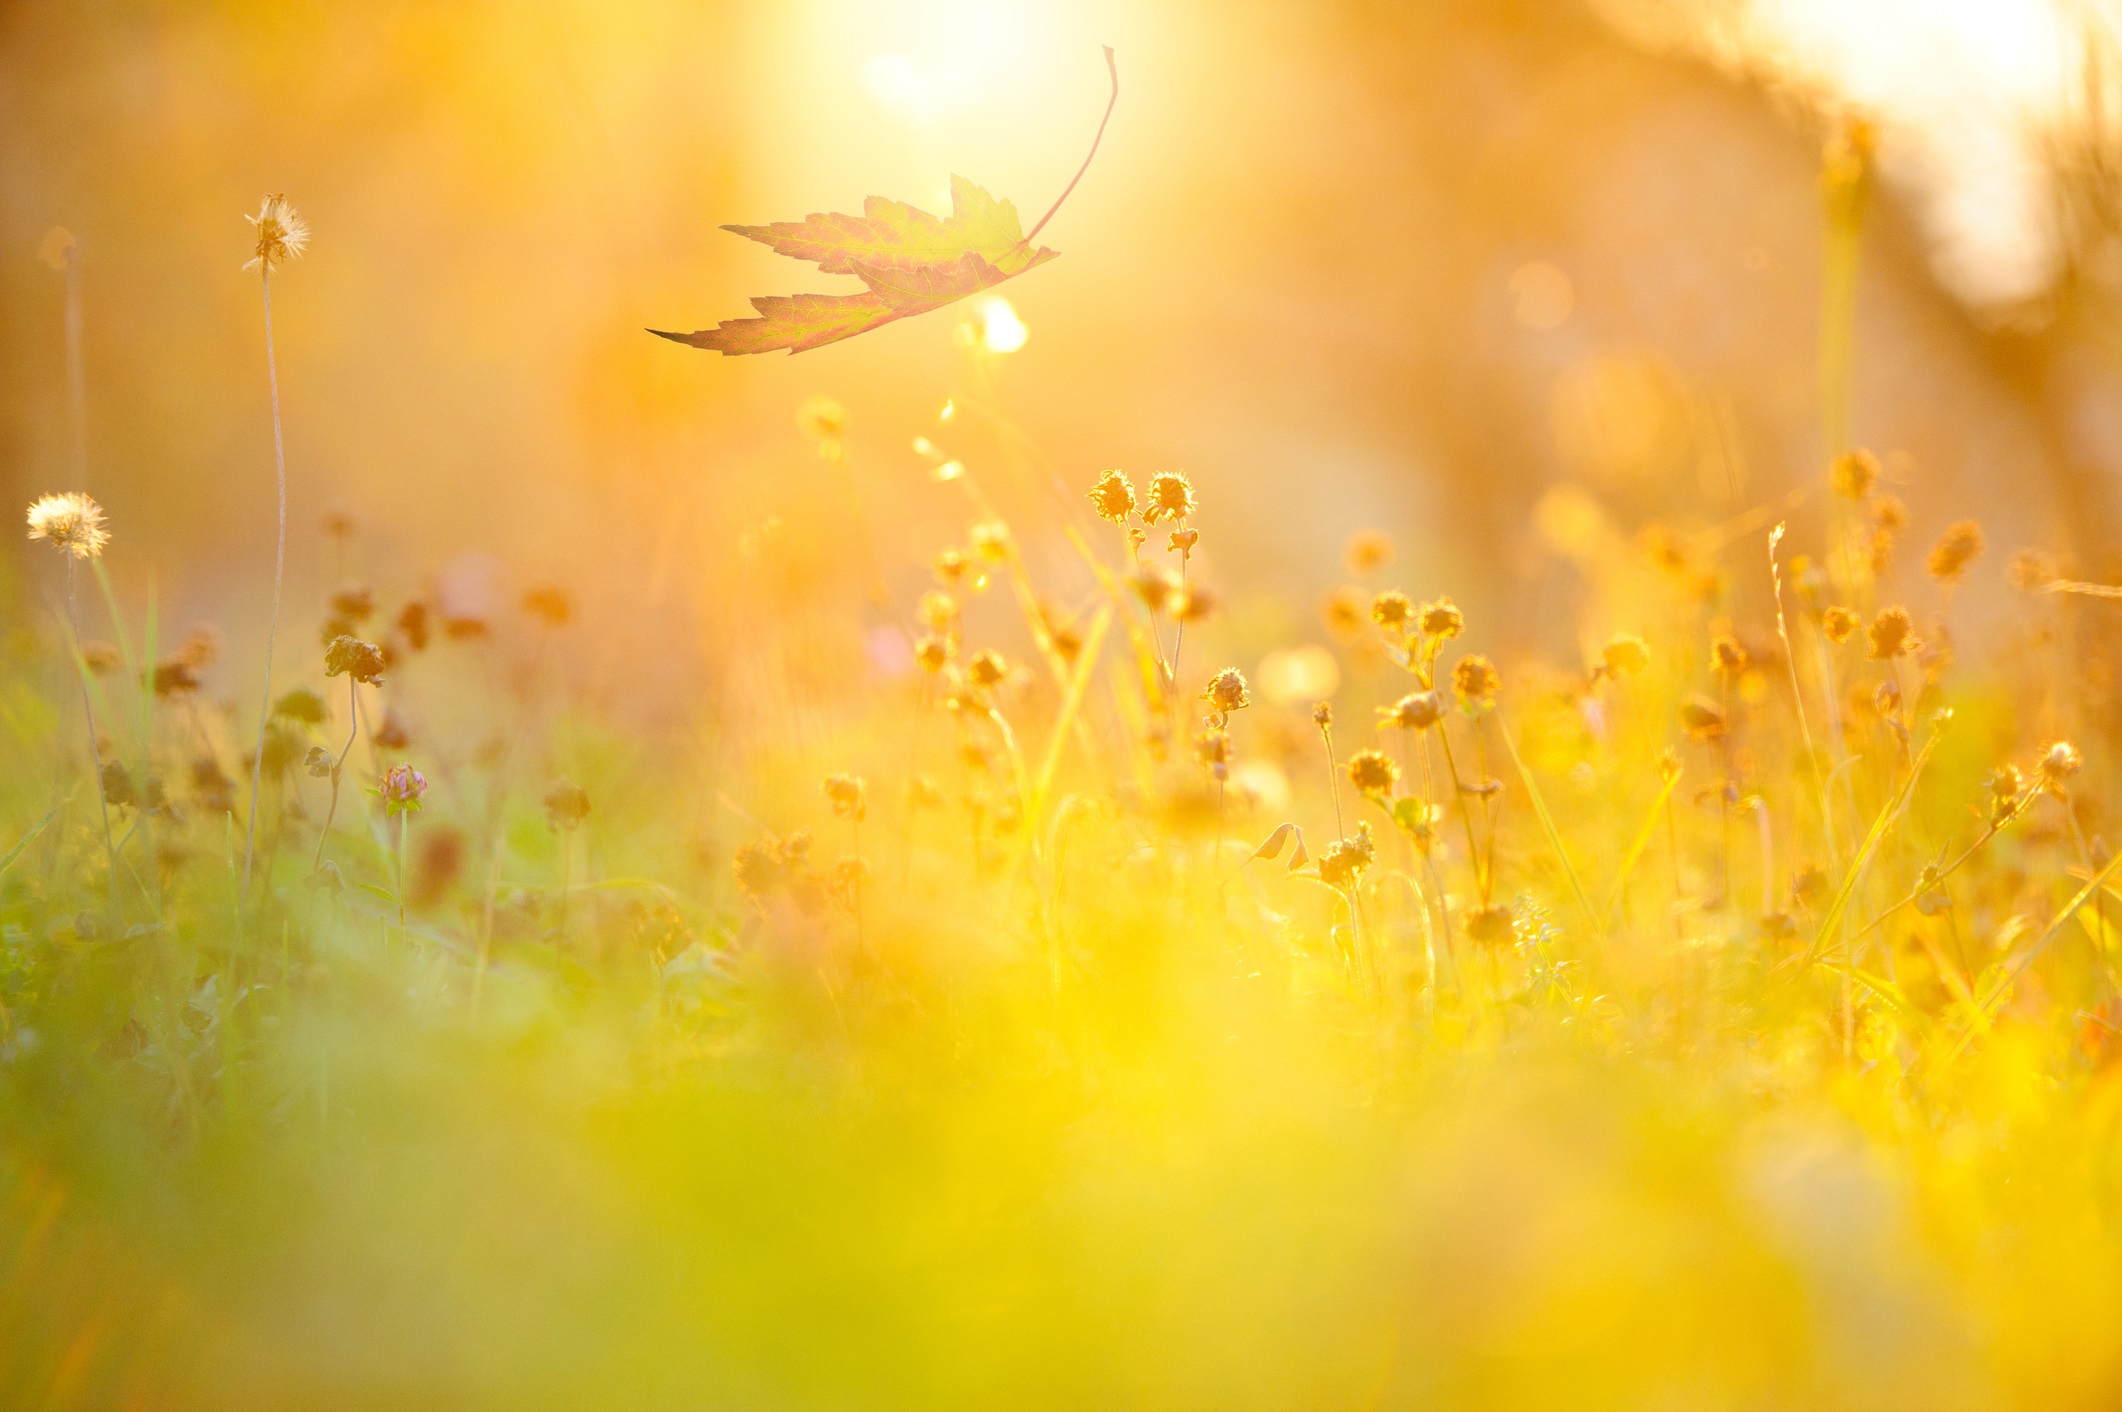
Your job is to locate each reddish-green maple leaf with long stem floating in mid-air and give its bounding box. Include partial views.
[649,47,1120,355]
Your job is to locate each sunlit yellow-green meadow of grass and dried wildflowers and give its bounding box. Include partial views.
[0,132,2122,1410]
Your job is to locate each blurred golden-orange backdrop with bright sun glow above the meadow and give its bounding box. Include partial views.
[0,0,2122,707]
